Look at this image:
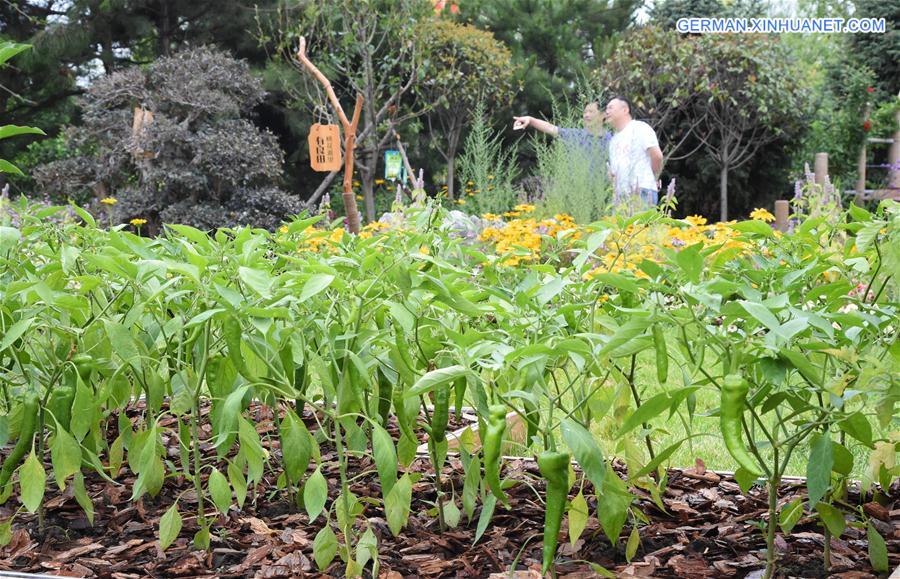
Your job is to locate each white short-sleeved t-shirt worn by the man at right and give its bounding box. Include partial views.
[609,120,659,195]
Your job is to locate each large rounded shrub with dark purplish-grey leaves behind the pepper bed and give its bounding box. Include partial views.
[36,48,300,229]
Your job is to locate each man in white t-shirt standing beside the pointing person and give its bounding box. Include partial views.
[606,97,663,206]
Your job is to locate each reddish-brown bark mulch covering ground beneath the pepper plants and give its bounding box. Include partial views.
[0,409,900,579]
